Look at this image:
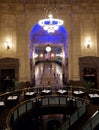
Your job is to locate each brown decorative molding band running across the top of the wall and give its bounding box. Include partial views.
[0,0,99,13]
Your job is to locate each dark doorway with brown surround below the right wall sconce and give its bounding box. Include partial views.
[79,56,99,89]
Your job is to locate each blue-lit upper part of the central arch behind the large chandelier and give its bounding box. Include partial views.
[30,24,68,56]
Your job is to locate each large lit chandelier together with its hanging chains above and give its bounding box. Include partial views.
[38,0,64,33]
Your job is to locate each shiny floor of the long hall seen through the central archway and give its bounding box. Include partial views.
[35,62,63,86]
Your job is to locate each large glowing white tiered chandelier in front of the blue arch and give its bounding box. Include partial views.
[38,1,64,33]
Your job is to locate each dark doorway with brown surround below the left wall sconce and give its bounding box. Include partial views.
[0,57,19,91]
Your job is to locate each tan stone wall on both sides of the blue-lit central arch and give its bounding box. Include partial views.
[0,1,99,84]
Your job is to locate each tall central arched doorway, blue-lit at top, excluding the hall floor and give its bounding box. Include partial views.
[30,24,68,84]
